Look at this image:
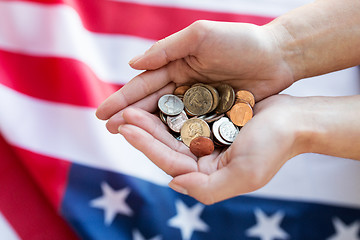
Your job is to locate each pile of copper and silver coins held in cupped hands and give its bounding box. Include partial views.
[158,83,255,157]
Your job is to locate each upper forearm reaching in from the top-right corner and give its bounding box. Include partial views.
[265,0,360,80]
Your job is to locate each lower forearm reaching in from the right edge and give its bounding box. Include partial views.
[295,95,360,160]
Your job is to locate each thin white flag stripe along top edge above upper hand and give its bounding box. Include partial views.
[113,0,313,17]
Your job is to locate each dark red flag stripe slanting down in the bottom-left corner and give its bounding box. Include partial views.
[0,135,78,240]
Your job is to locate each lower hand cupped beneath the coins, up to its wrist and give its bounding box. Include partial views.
[119,95,307,204]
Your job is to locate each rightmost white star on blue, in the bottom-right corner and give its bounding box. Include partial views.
[328,218,360,240]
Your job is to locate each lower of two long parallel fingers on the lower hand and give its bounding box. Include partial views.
[119,124,197,176]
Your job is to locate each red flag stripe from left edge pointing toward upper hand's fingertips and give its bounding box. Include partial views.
[0,50,121,108]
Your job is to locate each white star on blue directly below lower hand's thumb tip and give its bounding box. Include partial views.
[168,200,209,240]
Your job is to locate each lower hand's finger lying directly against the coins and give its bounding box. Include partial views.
[123,108,196,160]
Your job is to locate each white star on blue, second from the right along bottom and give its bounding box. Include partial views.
[246,209,289,240]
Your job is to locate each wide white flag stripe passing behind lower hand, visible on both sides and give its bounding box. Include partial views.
[0,85,360,206]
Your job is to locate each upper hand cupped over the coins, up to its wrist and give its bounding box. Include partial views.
[96,21,294,133]
